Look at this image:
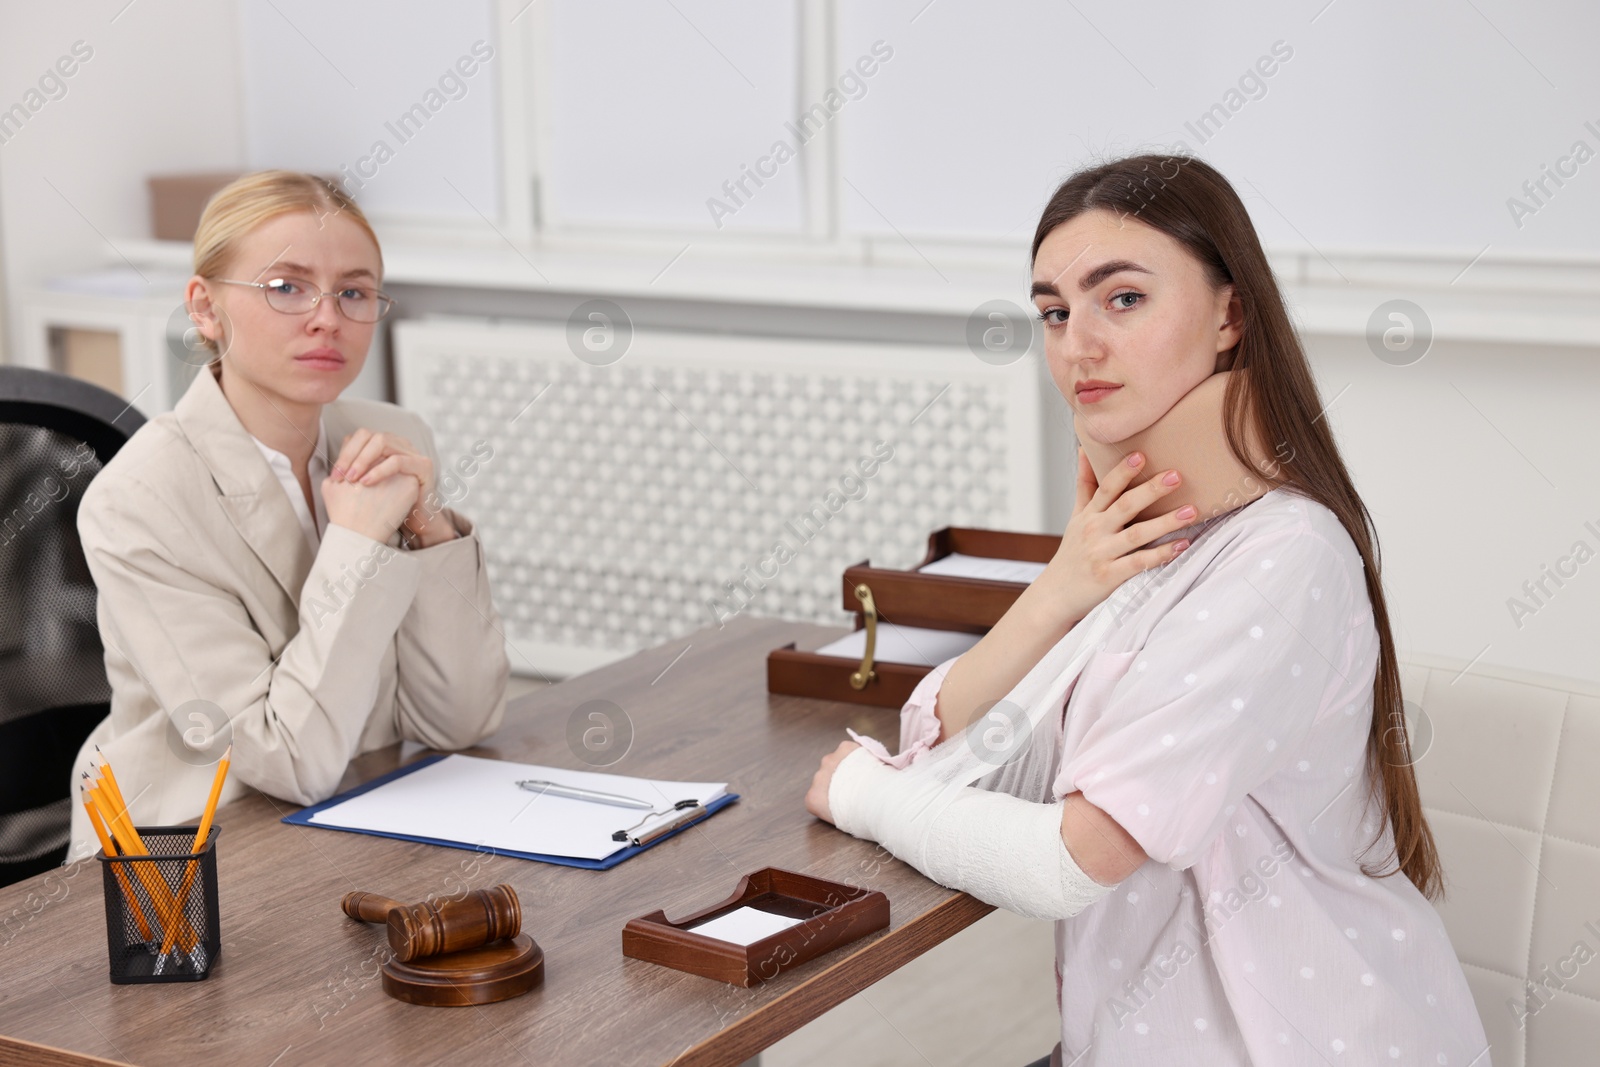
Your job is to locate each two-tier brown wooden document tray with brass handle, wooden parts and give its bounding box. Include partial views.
[766,526,1061,707]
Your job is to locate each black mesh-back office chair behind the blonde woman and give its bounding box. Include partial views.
[0,366,144,886]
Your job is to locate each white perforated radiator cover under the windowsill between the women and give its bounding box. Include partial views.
[394,317,1043,677]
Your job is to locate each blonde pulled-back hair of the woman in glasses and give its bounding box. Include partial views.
[194,170,384,354]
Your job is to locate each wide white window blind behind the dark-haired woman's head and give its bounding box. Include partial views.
[835,0,1600,256]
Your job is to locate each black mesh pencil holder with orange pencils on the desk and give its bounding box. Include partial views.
[96,825,222,985]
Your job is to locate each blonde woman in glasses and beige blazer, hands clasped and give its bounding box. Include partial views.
[70,171,507,857]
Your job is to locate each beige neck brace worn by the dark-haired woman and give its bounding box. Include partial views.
[1077,371,1278,522]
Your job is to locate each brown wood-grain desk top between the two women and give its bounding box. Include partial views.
[0,619,992,1067]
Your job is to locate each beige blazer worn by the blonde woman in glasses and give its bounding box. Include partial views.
[70,371,509,859]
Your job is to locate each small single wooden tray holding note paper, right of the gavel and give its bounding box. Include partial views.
[622,867,890,987]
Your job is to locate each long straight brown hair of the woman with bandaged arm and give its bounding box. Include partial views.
[1030,155,1445,899]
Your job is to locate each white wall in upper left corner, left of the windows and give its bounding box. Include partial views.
[0,0,242,358]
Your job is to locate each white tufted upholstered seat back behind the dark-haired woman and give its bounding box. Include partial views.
[1400,654,1600,1067]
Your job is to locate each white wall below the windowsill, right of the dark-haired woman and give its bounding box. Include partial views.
[1314,341,1600,681]
